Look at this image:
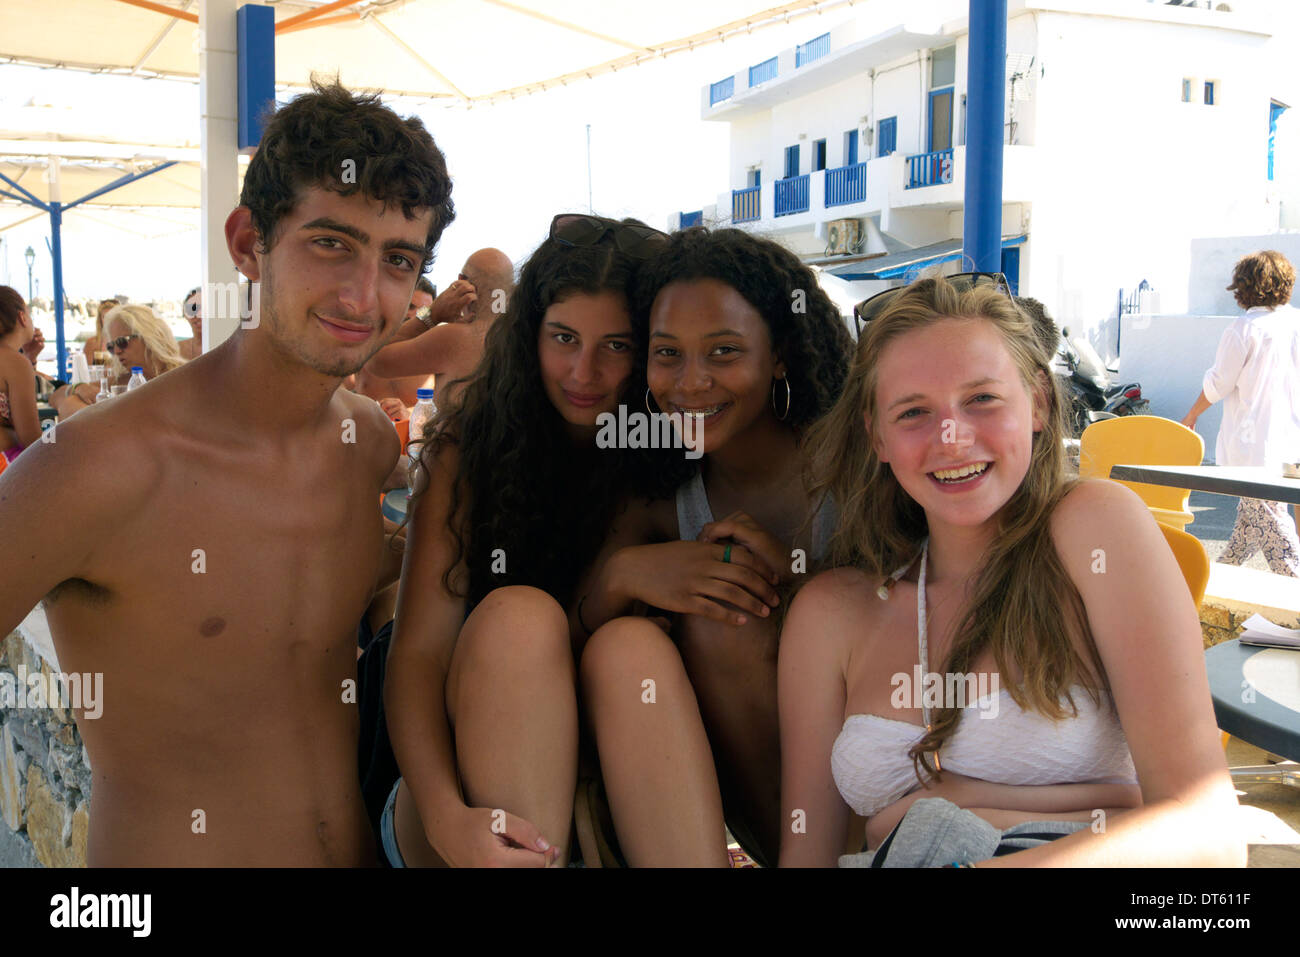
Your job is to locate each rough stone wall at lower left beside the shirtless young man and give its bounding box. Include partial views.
[0,632,91,867]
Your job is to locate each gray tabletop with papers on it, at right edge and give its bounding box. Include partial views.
[1205,640,1300,761]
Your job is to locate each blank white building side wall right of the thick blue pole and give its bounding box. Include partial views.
[1024,12,1270,339]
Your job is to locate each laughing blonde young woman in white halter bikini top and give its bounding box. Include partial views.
[780,277,1245,867]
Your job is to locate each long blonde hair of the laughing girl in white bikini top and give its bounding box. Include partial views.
[805,277,1106,778]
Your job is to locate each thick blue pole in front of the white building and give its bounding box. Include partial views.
[962,0,1006,273]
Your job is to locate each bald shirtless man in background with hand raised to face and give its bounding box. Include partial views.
[365,248,515,408]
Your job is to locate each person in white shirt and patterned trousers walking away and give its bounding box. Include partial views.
[1183,250,1300,577]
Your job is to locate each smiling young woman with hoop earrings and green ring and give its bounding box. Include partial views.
[572,228,852,866]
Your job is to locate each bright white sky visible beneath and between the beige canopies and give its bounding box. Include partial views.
[0,12,826,300]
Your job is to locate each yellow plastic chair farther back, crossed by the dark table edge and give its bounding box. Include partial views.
[1079,415,1205,529]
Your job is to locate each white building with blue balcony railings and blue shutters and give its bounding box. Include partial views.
[670,0,1300,374]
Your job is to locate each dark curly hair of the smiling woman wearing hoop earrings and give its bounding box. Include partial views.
[632,226,853,432]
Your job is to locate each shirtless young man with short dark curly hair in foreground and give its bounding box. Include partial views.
[0,78,454,866]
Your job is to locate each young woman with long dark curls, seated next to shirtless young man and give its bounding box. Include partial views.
[381,215,686,867]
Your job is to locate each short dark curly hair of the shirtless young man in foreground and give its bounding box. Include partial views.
[239,77,456,272]
